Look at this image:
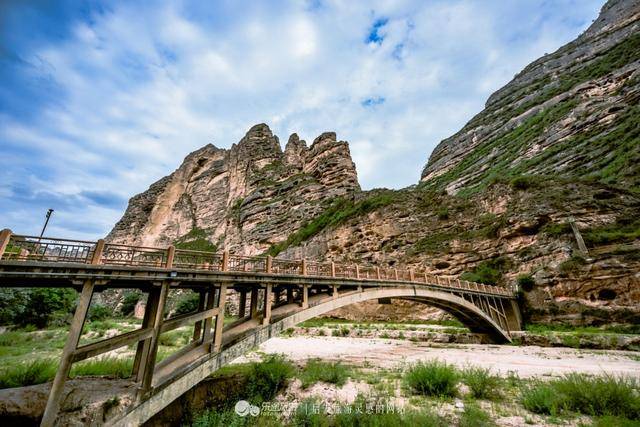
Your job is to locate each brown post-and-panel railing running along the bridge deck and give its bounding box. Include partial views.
[0,229,513,296]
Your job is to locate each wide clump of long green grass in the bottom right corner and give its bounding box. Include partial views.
[521,374,640,419]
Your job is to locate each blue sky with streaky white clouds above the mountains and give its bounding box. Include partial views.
[0,0,603,239]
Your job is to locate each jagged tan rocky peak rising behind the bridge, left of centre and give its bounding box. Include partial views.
[107,124,360,255]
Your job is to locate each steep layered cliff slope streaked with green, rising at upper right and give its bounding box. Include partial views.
[421,0,640,194]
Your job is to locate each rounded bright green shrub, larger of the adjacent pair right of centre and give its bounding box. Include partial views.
[404,360,460,396]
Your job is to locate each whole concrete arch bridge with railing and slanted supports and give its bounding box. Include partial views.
[0,229,521,426]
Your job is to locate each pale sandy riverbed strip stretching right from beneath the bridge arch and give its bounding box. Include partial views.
[238,337,640,378]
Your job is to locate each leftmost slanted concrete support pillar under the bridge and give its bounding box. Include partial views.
[40,280,94,427]
